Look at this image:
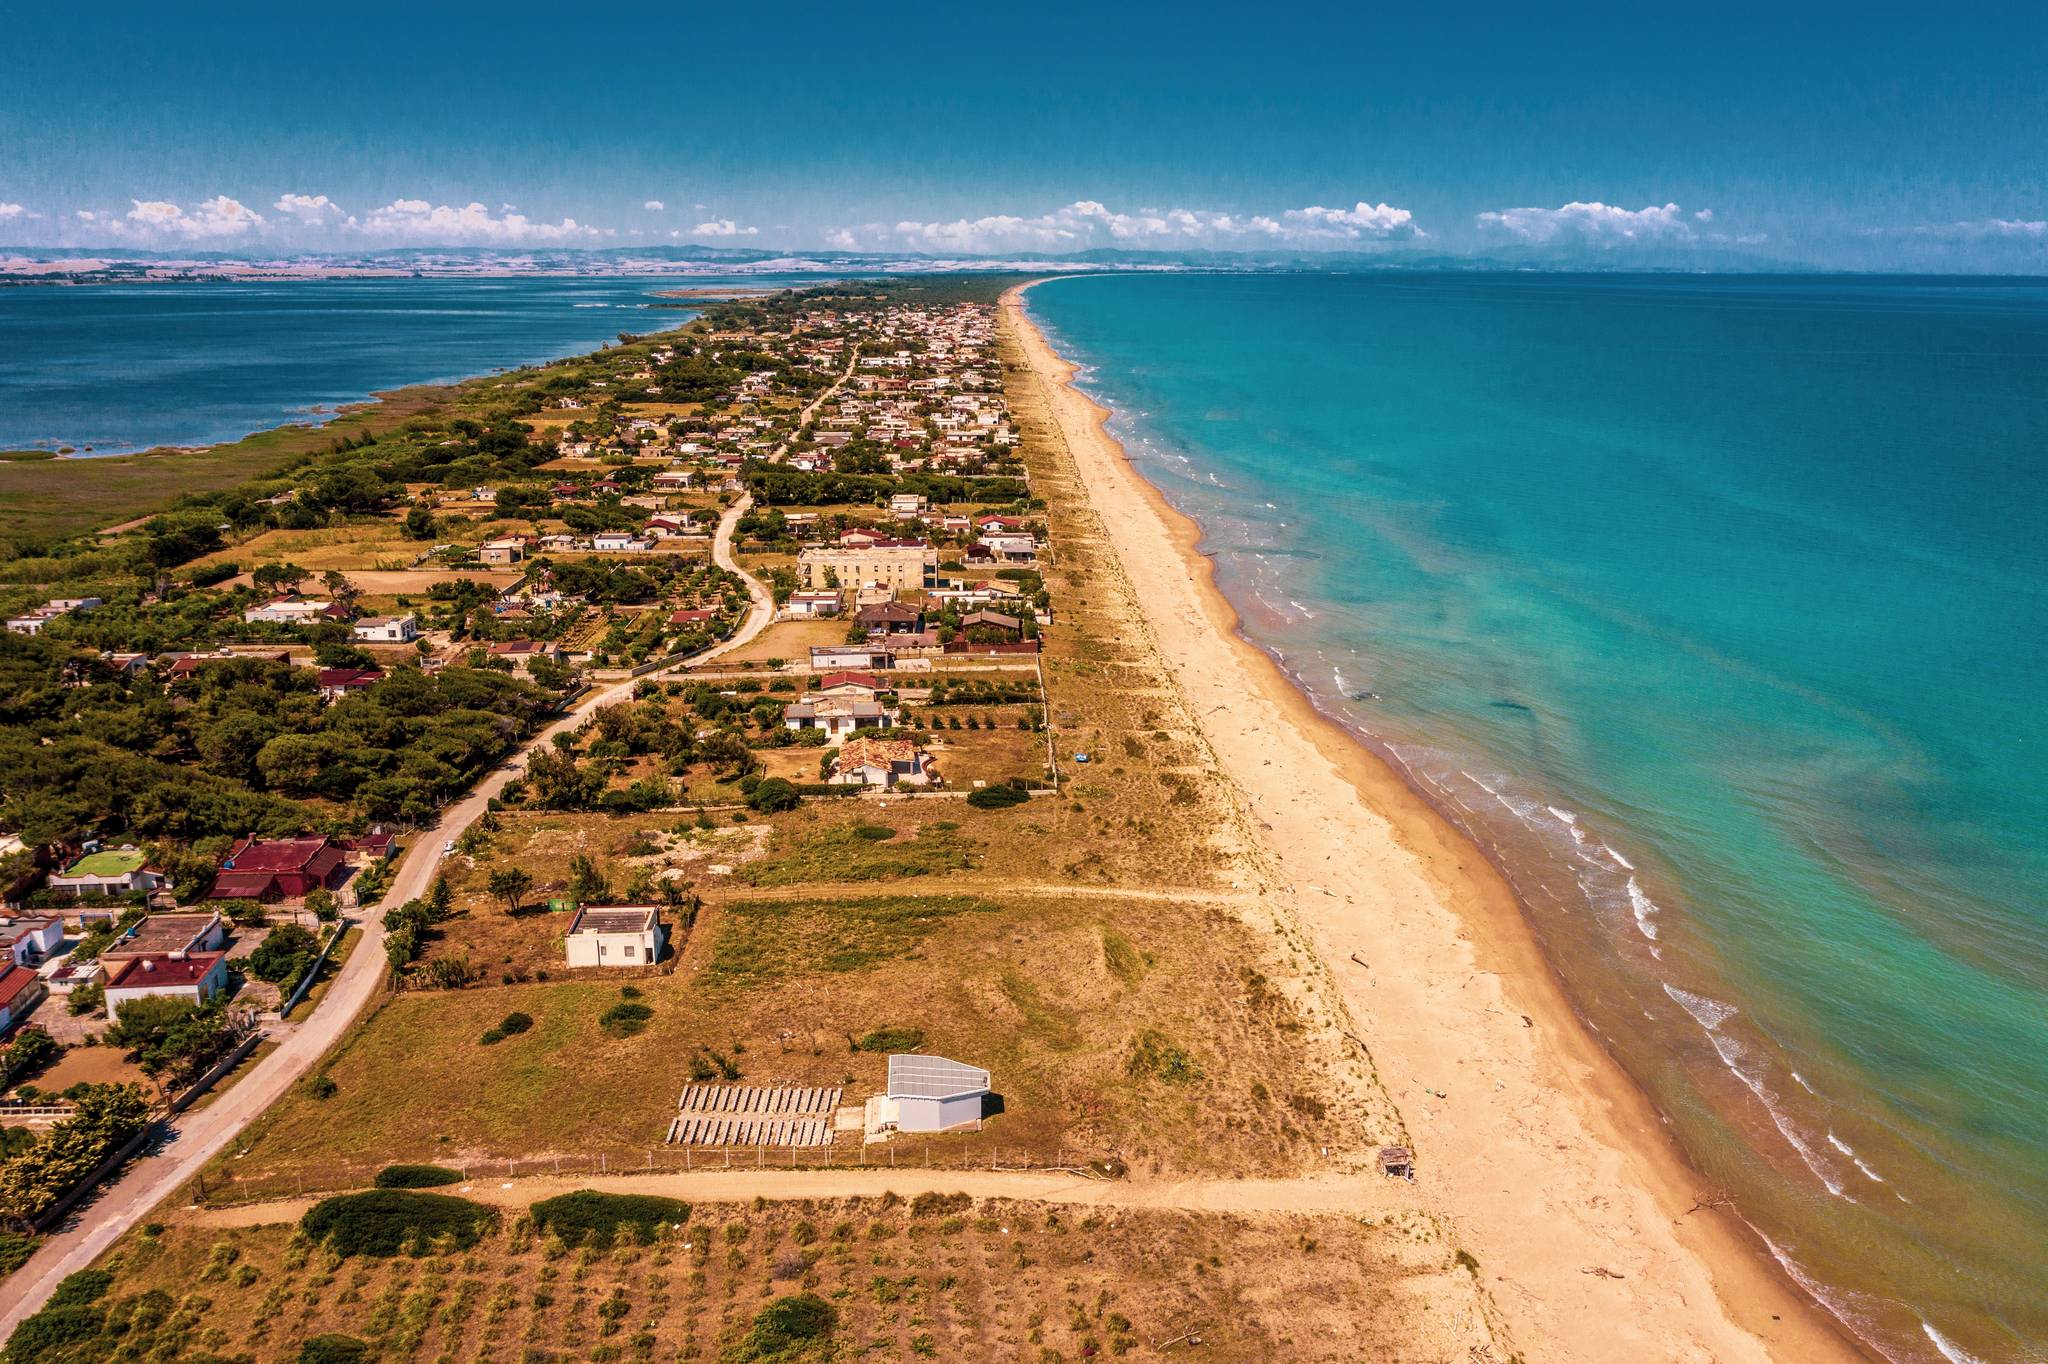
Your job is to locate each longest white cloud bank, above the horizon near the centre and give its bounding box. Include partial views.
[880,199,1427,252]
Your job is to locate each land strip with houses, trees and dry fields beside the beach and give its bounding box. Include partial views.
[0,281,1548,1360]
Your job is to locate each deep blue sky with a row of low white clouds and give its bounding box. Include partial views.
[0,0,2048,270]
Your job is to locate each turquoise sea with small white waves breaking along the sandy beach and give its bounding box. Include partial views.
[1028,274,2048,1362]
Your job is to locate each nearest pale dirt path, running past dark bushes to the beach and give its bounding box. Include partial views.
[178,1167,1427,1227]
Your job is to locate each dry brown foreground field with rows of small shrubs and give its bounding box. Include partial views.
[64,1196,1495,1364]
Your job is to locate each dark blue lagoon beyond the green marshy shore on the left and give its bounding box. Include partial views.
[0,276,760,455]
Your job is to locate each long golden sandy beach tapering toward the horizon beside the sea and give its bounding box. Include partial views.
[1001,285,1868,1364]
